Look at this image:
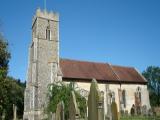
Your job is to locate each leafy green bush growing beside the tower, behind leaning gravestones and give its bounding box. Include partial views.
[47,82,86,119]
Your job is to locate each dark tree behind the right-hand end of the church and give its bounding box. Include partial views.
[142,66,160,106]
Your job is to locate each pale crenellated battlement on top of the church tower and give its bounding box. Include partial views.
[32,8,59,25]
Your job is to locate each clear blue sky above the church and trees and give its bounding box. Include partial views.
[0,0,160,81]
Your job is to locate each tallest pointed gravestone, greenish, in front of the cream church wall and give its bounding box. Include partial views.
[88,79,104,120]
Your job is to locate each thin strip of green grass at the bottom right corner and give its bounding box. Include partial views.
[120,116,160,120]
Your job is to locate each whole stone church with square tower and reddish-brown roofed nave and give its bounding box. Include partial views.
[23,9,150,120]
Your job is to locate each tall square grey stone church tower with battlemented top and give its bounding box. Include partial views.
[23,9,59,120]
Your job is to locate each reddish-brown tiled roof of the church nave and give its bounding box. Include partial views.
[60,59,146,84]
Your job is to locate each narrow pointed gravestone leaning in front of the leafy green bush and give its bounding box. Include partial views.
[69,91,80,120]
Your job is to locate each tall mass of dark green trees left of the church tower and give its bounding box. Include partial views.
[0,33,25,120]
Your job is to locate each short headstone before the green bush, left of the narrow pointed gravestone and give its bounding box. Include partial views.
[55,101,64,120]
